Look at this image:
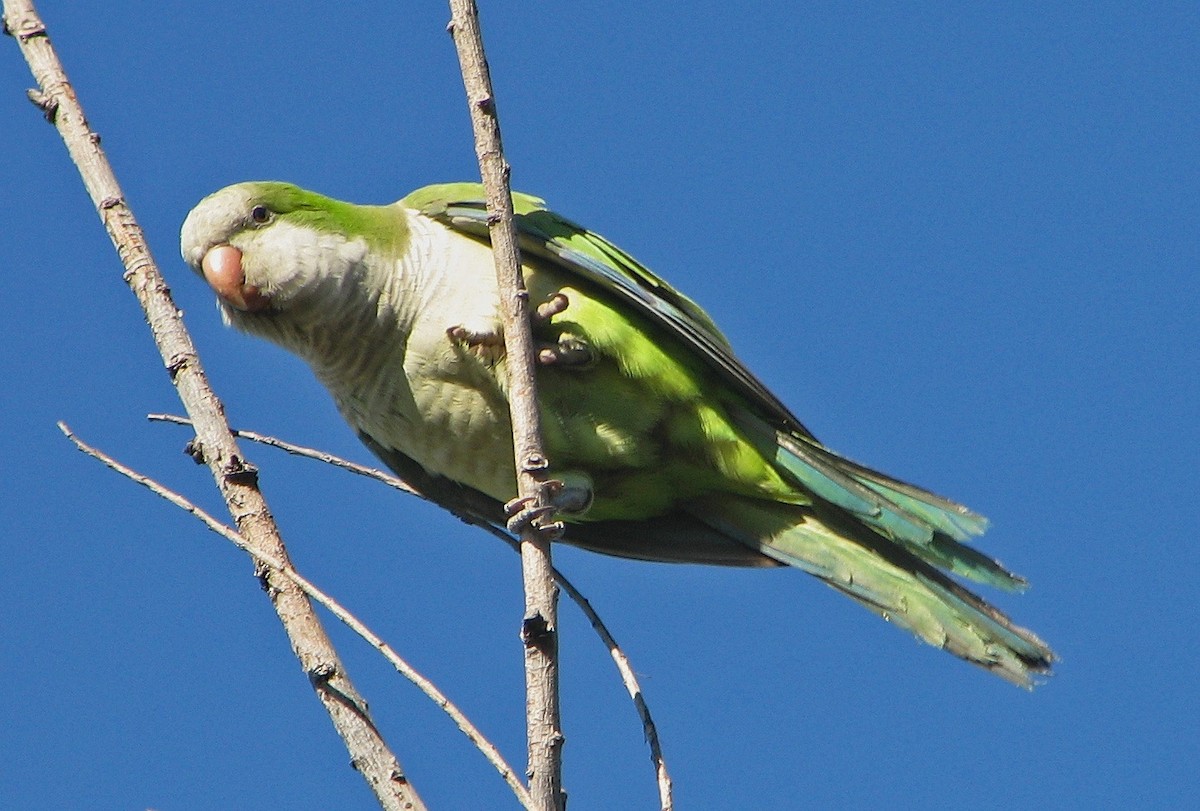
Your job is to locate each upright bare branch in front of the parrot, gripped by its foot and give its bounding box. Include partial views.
[450,0,565,811]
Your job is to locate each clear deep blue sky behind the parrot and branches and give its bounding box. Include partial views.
[0,0,1200,811]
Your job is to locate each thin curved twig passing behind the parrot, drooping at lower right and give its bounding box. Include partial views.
[146,414,674,811]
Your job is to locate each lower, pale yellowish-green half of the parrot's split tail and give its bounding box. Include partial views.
[688,495,1055,687]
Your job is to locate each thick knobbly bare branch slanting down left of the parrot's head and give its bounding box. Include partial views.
[4,0,425,811]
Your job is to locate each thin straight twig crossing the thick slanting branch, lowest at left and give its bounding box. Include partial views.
[58,424,532,809]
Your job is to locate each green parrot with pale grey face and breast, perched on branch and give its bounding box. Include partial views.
[181,181,1055,686]
